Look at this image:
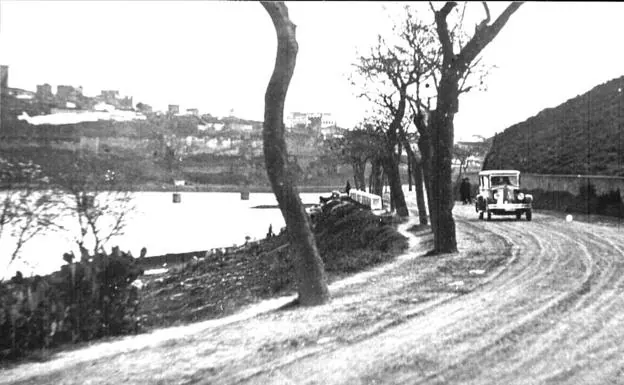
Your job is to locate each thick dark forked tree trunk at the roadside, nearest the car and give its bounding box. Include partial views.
[429,2,522,253]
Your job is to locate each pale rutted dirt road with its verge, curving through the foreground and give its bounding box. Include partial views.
[0,205,624,384]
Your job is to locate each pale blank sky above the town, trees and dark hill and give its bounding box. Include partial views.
[0,0,624,140]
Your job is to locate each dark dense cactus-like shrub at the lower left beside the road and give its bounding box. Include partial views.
[0,248,142,359]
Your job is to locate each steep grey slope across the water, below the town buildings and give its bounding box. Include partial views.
[0,116,351,190]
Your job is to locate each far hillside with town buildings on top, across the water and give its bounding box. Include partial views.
[0,66,350,190]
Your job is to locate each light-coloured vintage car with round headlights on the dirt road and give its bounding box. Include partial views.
[475,170,533,221]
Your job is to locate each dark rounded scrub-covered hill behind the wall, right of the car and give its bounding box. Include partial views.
[483,76,624,176]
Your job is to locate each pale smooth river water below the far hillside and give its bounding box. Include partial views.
[0,192,329,279]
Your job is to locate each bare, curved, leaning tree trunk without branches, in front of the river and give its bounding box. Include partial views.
[262,2,329,306]
